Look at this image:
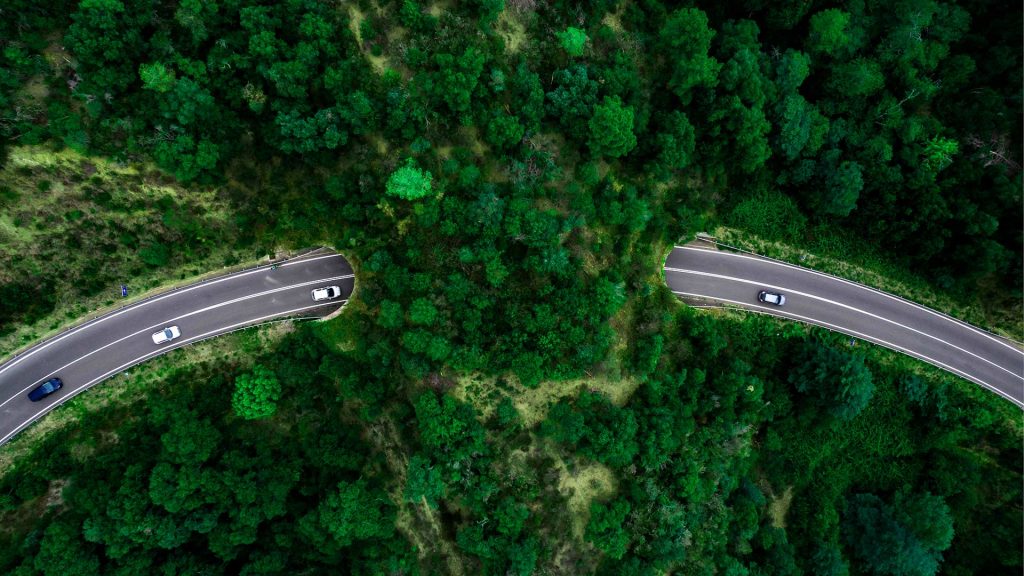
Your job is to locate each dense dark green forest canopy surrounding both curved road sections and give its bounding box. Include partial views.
[0,0,1022,575]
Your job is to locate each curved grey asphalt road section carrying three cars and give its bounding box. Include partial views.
[0,250,355,444]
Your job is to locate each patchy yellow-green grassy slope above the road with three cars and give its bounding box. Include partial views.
[0,147,255,358]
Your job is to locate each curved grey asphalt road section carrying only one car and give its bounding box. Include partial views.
[665,241,1024,408]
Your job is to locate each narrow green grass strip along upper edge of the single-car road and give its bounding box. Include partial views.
[712,223,1024,341]
